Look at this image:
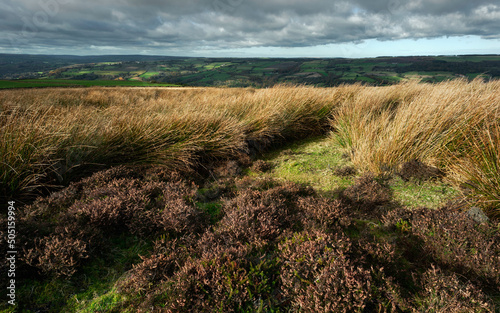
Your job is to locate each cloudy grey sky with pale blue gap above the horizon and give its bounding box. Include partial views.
[0,0,500,58]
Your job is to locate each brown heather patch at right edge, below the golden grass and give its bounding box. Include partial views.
[384,208,500,288]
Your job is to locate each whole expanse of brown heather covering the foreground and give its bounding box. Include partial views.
[2,162,500,312]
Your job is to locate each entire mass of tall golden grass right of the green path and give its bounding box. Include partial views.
[331,79,500,215]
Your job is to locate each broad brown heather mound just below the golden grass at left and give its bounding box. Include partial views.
[68,179,202,236]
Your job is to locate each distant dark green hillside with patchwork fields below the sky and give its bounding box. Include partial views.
[0,54,500,87]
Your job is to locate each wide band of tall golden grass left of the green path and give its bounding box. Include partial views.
[0,85,352,196]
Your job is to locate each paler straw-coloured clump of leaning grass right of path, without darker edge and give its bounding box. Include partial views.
[332,80,500,173]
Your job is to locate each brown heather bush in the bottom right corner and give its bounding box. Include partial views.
[415,266,495,313]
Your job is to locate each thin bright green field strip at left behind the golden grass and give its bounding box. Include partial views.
[0,79,179,88]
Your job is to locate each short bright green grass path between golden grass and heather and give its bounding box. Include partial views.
[252,137,459,208]
